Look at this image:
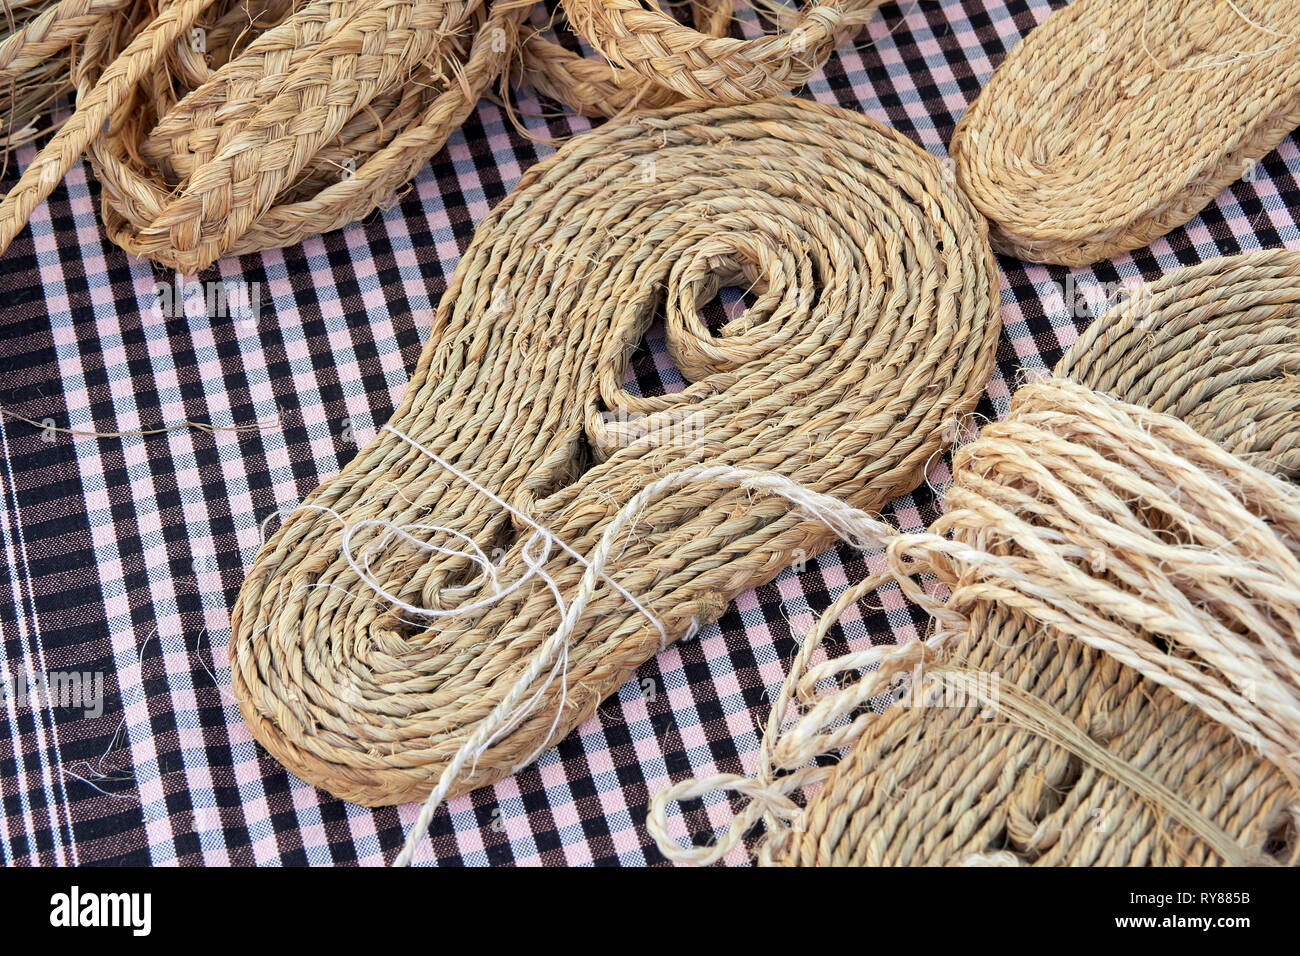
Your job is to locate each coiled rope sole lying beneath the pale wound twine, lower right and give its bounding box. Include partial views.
[764,251,1300,866]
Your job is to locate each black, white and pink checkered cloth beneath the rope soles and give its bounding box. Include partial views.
[0,0,1300,865]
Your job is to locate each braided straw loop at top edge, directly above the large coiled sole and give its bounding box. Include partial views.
[524,0,881,116]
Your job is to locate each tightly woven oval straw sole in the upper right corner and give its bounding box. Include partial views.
[950,0,1300,265]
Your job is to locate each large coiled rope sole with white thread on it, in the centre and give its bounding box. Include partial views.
[223,99,1000,805]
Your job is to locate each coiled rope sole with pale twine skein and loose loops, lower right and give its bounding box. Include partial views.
[650,252,1300,865]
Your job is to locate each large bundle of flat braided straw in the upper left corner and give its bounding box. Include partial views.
[0,0,528,273]
